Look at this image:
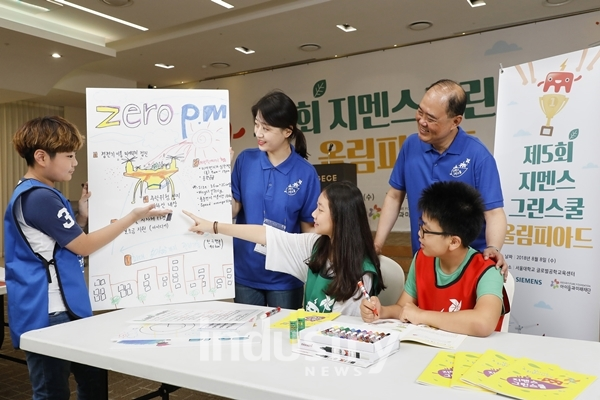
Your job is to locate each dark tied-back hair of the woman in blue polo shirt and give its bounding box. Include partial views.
[252,90,310,159]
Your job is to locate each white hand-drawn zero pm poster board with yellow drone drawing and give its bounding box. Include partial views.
[86,89,235,310]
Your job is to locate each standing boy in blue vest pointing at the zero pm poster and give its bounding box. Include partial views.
[4,117,170,400]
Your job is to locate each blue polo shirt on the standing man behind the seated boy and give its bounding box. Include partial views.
[389,126,504,254]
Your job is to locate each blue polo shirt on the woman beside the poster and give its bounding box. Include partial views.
[231,146,321,290]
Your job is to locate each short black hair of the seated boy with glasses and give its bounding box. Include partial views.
[419,181,485,247]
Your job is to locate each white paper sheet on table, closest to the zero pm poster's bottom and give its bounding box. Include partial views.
[129,309,264,324]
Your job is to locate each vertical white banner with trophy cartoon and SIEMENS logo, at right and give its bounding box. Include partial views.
[494,48,600,341]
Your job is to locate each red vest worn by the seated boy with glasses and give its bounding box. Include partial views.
[415,250,510,332]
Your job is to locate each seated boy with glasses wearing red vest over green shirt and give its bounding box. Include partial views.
[361,181,509,337]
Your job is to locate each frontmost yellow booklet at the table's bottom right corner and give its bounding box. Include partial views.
[478,358,596,400]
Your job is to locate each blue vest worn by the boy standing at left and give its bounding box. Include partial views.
[4,179,92,348]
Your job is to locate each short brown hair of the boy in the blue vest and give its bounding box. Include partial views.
[13,116,83,166]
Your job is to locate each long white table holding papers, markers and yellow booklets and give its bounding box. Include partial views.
[21,302,600,400]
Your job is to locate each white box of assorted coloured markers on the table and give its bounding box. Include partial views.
[298,321,400,361]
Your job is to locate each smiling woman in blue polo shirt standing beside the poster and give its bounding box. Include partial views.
[231,91,321,309]
